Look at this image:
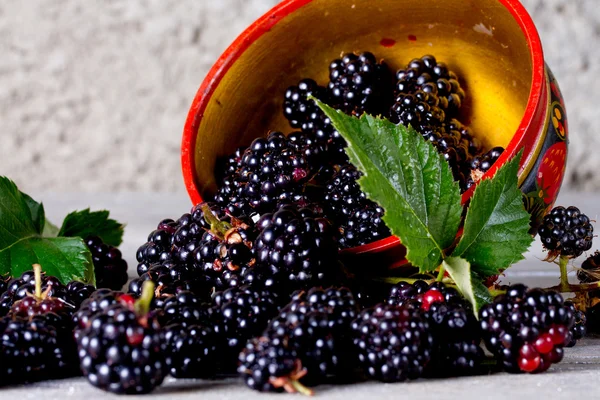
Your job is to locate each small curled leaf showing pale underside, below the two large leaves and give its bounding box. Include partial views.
[442,257,491,316]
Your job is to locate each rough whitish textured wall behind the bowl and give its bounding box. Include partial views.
[0,0,600,191]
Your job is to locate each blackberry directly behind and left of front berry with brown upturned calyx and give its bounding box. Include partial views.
[212,286,279,362]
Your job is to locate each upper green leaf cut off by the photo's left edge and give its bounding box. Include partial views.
[0,176,39,250]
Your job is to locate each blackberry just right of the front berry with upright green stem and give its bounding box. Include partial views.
[161,323,221,378]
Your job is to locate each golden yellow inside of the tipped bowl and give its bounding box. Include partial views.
[194,0,532,195]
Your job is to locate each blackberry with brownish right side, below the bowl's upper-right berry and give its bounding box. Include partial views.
[389,90,445,134]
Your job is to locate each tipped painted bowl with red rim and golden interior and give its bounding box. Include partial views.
[181,0,567,268]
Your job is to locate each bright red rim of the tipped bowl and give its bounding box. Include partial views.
[181,0,545,253]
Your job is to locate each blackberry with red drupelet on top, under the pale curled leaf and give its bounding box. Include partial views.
[387,280,483,376]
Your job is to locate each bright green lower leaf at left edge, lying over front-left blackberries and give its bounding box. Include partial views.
[0,236,95,284]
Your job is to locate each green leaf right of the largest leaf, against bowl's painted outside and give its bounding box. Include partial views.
[452,152,533,277]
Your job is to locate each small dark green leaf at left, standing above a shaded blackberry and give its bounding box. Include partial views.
[58,208,124,246]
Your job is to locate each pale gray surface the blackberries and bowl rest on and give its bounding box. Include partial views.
[0,191,600,400]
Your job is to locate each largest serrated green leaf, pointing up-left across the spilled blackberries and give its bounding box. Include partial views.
[315,100,462,272]
